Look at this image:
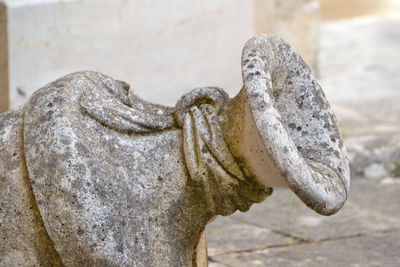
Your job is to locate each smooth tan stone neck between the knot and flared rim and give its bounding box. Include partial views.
[220,89,288,187]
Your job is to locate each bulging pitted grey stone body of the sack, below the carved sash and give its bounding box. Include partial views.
[24,73,208,266]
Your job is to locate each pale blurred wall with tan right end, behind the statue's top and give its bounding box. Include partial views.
[0,0,318,112]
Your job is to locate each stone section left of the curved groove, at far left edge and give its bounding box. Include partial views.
[0,109,60,266]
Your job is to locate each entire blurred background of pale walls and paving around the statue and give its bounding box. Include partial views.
[0,0,400,267]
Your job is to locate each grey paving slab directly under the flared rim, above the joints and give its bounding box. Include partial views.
[223,179,400,245]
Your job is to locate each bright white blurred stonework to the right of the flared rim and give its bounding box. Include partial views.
[319,16,400,178]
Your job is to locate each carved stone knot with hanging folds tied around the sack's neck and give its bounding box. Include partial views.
[176,87,272,218]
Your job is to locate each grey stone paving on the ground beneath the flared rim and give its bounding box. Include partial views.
[206,178,400,267]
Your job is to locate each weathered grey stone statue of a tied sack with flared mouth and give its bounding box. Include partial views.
[0,35,349,266]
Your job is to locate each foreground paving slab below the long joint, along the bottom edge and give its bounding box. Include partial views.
[211,232,400,267]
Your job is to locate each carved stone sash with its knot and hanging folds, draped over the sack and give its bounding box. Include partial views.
[80,76,272,218]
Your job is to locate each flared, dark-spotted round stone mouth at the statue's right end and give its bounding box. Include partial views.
[225,35,350,215]
